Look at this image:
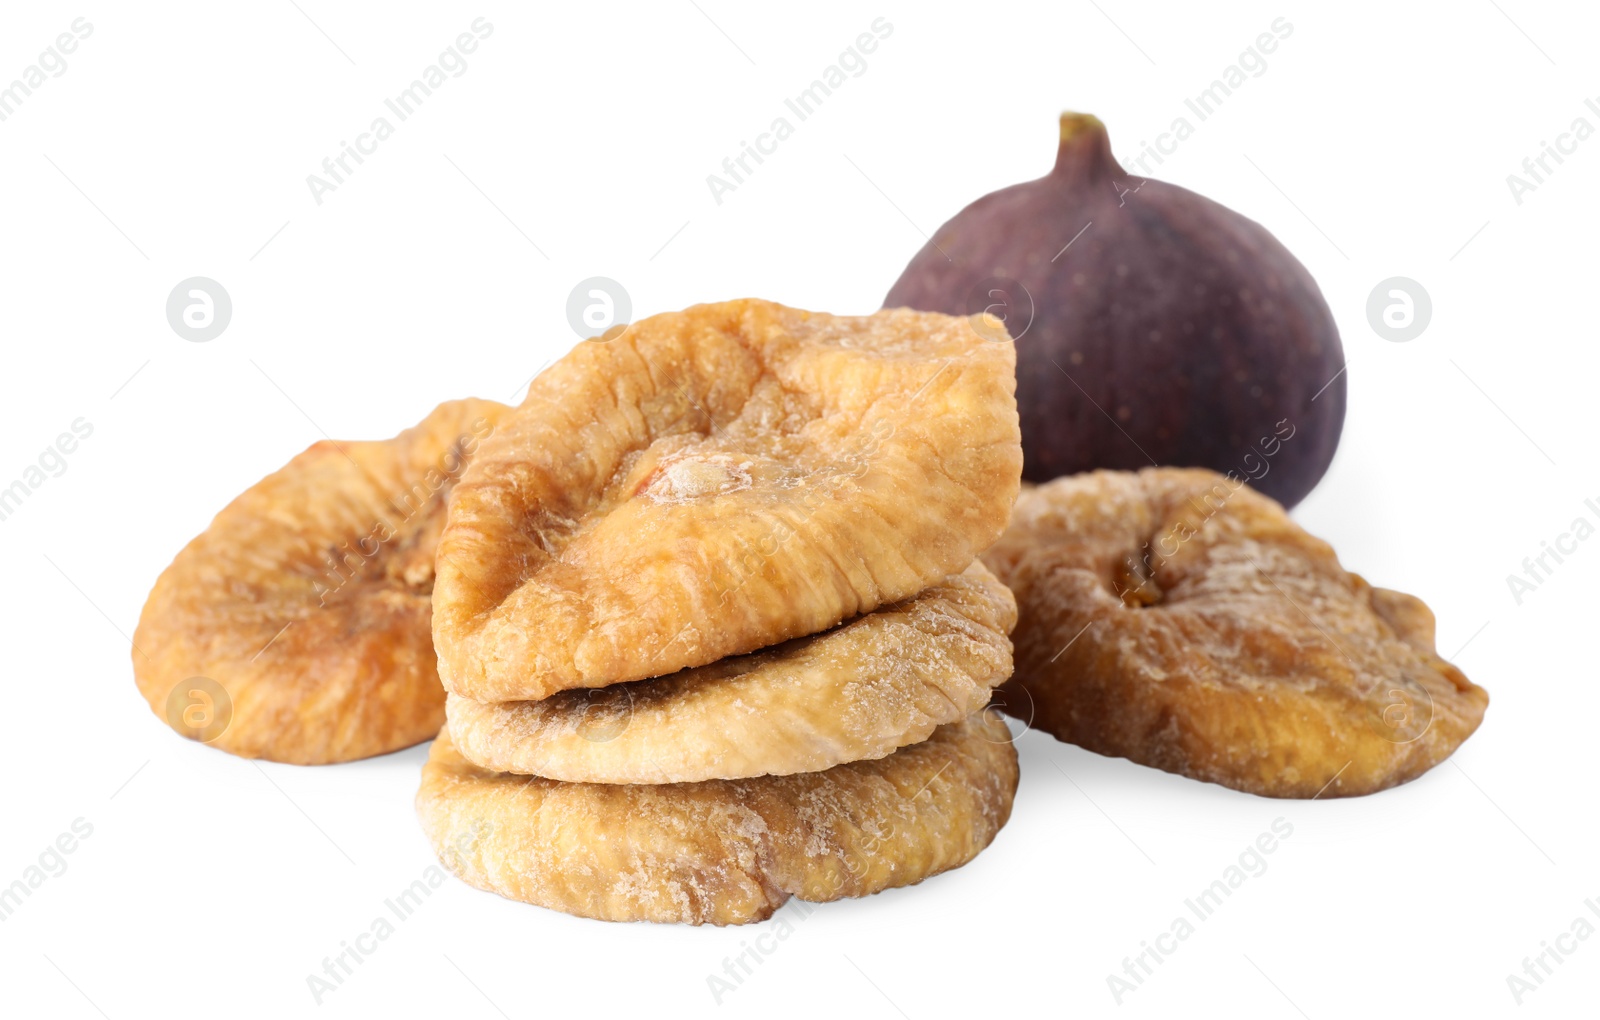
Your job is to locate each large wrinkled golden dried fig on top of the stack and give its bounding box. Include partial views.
[434,301,1022,702]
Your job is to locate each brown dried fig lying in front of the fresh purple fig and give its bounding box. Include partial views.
[984,468,1488,798]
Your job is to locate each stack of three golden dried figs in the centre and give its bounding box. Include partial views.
[418,301,1022,924]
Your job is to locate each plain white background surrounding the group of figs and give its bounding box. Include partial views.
[0,0,1600,1020]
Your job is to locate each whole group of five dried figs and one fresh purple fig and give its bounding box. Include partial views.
[134,115,1488,924]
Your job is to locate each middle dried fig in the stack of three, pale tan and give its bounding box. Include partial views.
[448,563,1016,783]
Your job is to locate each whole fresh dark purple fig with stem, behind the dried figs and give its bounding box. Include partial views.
[883,114,1346,507]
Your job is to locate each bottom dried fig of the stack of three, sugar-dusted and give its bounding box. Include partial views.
[416,713,1018,924]
